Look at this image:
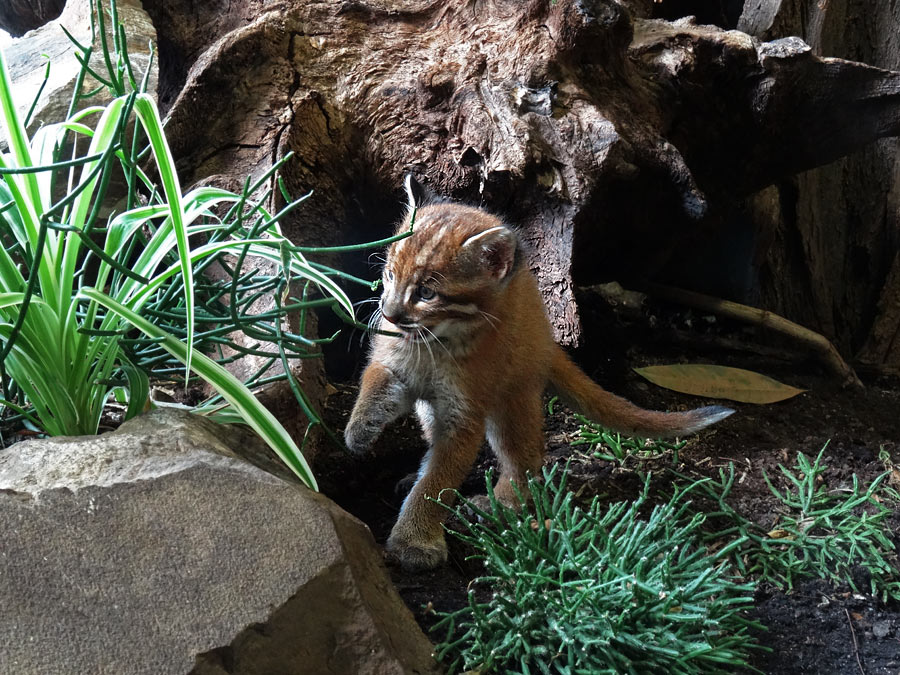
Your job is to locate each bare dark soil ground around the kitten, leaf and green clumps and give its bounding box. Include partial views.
[317,302,900,675]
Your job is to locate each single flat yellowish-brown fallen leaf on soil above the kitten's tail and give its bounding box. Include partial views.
[634,363,806,403]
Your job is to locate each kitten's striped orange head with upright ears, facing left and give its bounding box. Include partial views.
[381,176,521,340]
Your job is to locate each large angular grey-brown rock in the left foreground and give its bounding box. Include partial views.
[0,410,438,675]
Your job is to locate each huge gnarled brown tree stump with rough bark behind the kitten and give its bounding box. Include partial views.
[146,0,900,354]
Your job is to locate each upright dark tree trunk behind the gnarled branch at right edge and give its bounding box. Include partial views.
[738,0,900,368]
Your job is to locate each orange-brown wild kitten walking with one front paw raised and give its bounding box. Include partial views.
[344,177,733,570]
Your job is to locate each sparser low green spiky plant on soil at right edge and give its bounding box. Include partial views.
[693,445,900,601]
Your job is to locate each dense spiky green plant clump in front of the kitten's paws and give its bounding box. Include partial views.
[434,467,756,674]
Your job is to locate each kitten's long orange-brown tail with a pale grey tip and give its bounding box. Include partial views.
[550,347,734,438]
